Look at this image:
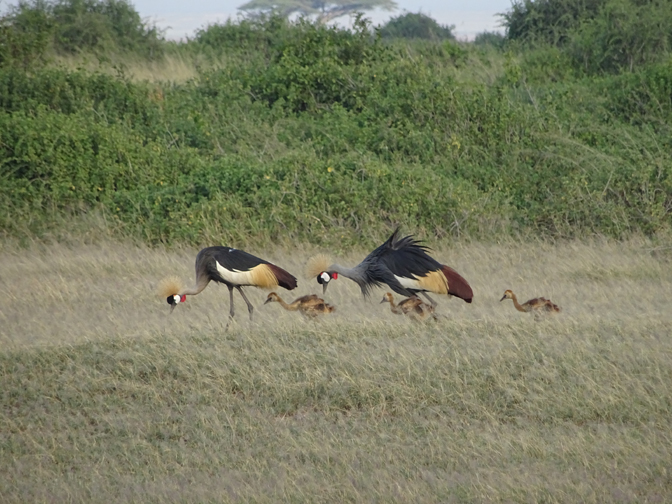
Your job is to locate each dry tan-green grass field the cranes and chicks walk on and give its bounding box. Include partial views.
[0,240,672,502]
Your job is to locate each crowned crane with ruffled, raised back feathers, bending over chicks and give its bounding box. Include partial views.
[306,228,474,307]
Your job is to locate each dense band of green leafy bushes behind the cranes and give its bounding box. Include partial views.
[0,0,672,248]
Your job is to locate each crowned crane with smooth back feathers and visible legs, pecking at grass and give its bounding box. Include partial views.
[159,246,296,328]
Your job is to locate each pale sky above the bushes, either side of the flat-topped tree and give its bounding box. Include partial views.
[130,0,511,40]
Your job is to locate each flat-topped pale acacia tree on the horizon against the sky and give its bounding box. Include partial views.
[238,0,397,23]
